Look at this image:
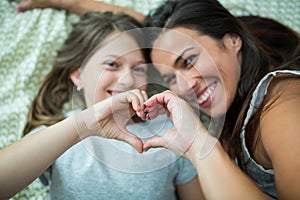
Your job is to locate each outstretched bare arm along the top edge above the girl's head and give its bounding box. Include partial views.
[17,0,145,21]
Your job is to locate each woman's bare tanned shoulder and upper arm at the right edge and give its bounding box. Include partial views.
[259,70,300,189]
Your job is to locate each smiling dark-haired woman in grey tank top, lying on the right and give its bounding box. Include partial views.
[144,0,300,199]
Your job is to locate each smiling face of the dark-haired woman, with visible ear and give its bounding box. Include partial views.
[151,28,242,117]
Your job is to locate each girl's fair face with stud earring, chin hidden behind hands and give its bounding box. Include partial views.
[71,33,147,106]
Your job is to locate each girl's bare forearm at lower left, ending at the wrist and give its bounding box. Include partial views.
[0,117,80,199]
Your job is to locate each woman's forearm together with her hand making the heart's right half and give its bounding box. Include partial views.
[144,91,268,200]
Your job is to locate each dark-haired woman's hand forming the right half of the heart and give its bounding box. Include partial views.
[143,91,211,157]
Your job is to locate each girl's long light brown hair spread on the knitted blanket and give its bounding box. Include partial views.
[23,12,148,135]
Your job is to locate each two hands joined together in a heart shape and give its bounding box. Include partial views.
[77,90,201,155]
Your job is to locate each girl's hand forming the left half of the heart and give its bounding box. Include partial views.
[75,89,148,153]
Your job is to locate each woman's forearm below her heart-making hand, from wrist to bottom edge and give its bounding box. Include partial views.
[187,134,270,200]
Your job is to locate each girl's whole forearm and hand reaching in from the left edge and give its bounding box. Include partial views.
[0,90,148,199]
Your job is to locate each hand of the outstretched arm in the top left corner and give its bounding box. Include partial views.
[17,0,78,12]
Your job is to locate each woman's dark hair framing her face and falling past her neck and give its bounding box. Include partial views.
[145,0,269,167]
